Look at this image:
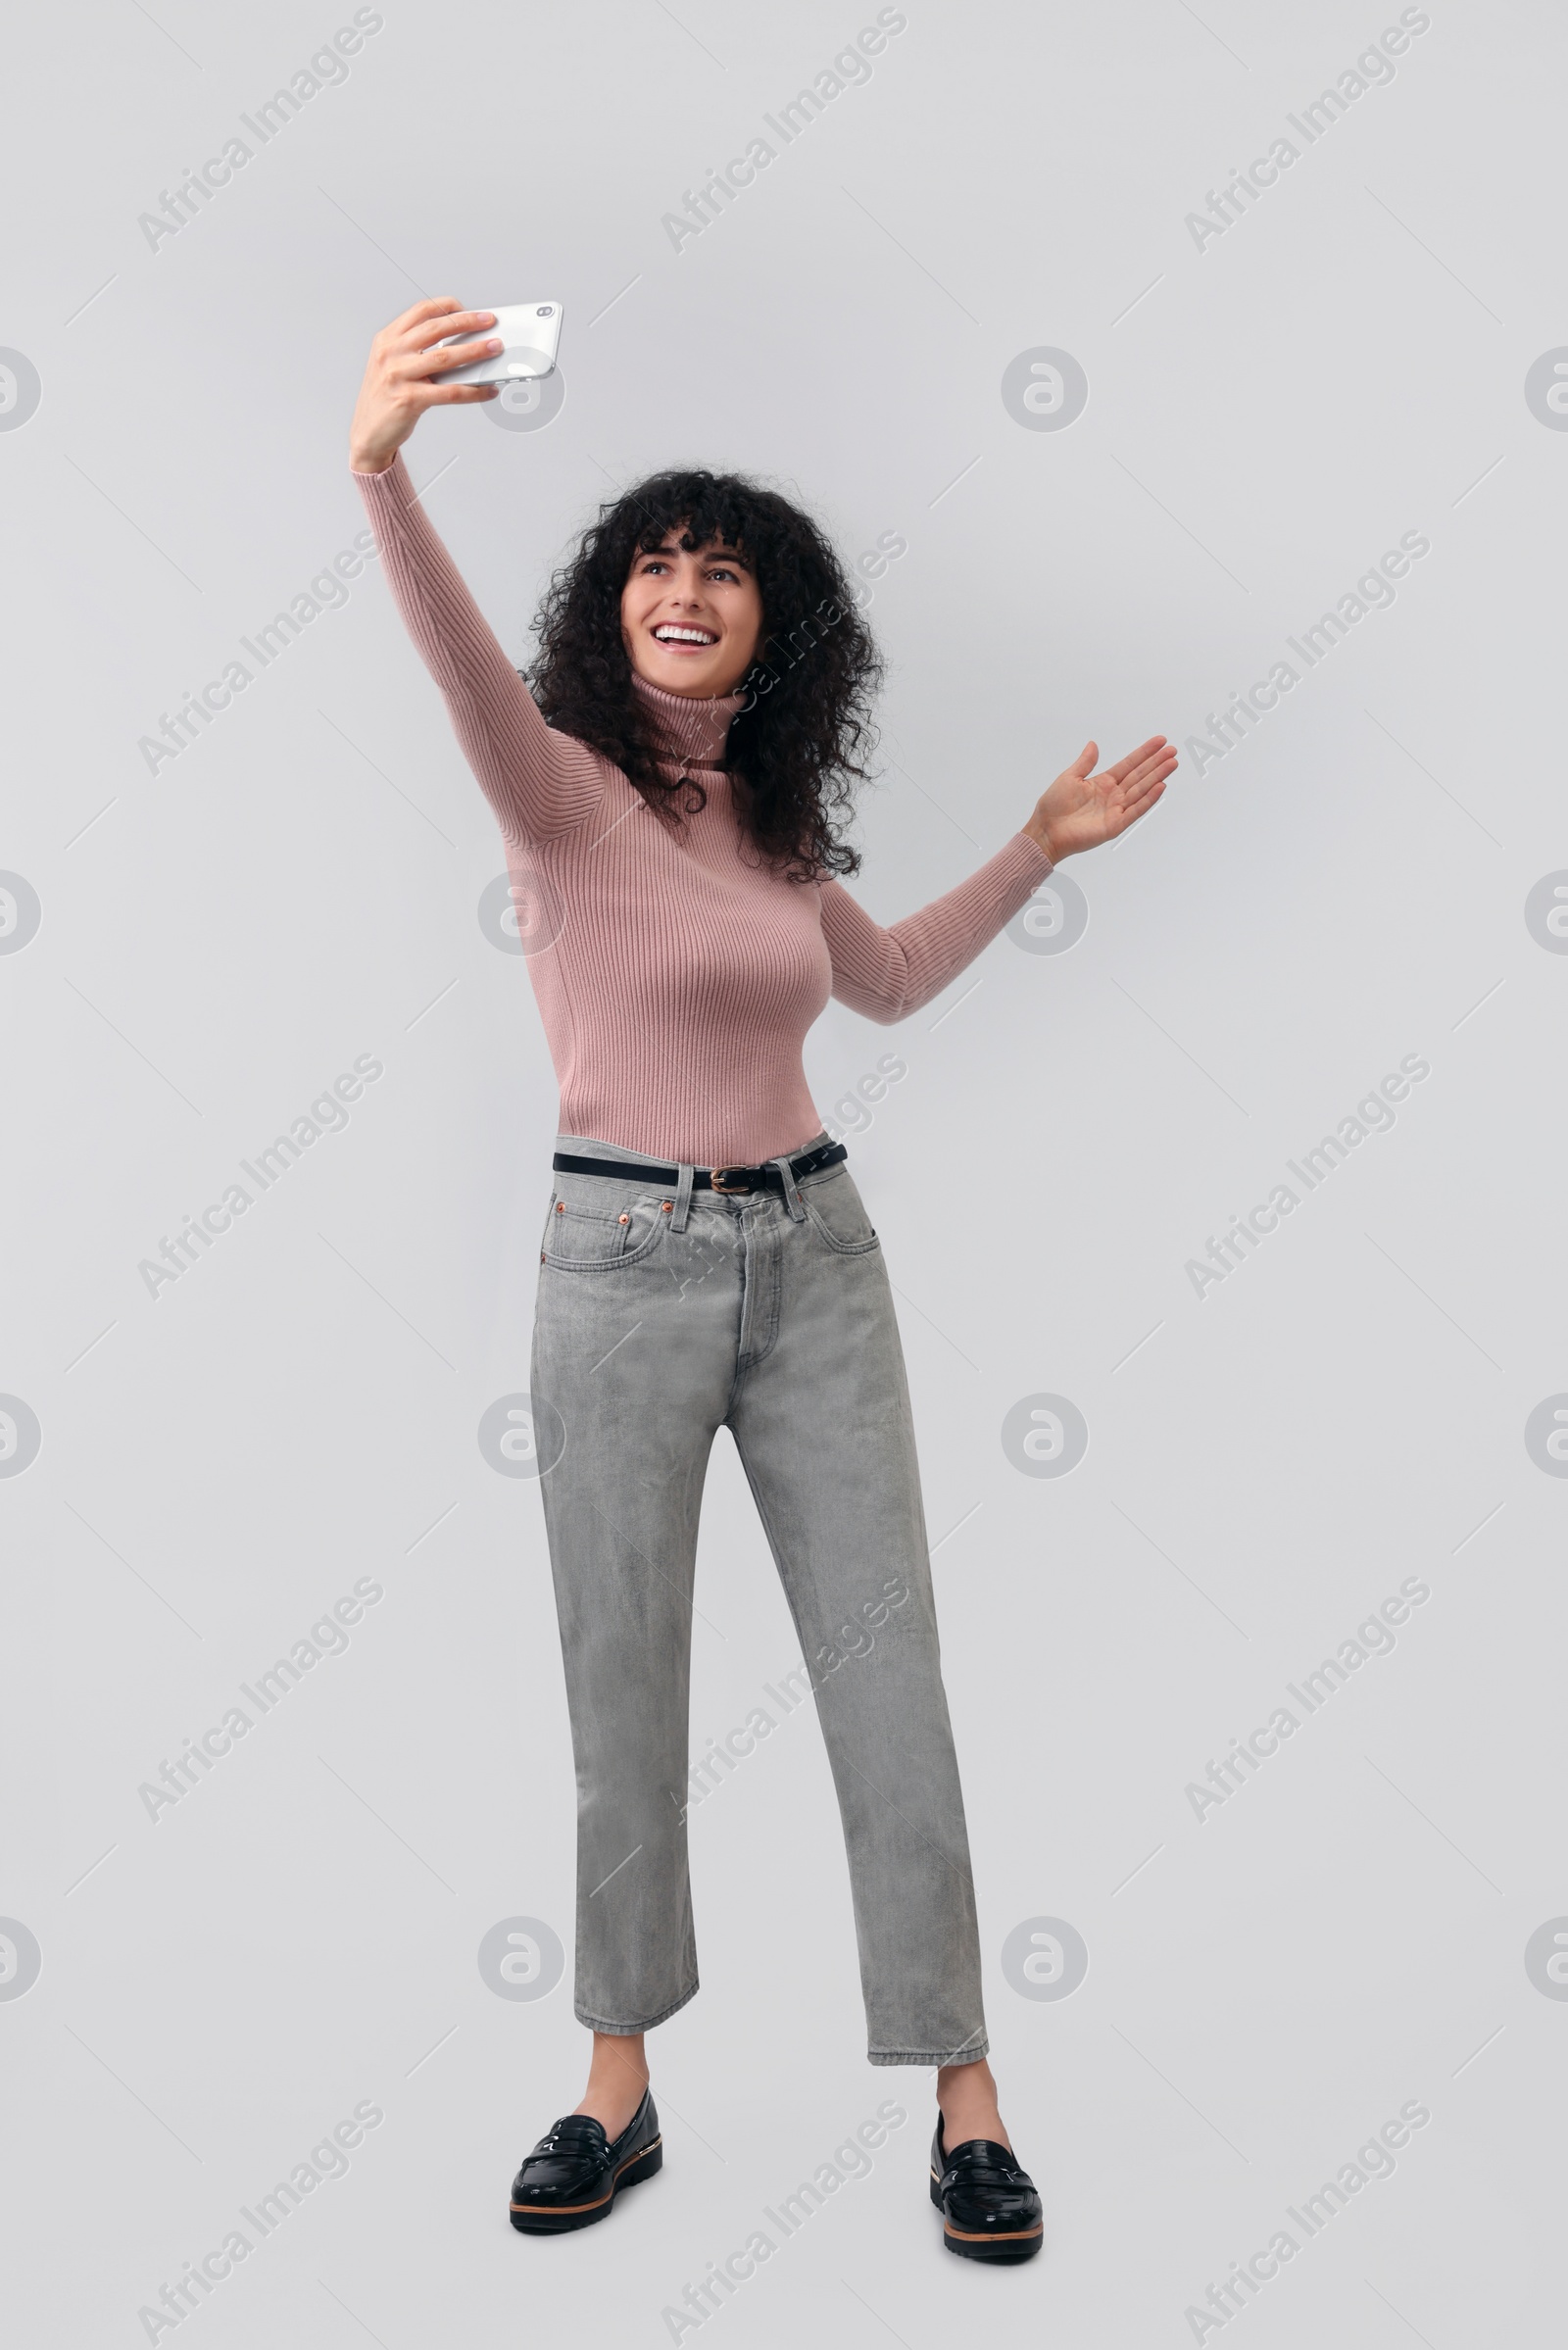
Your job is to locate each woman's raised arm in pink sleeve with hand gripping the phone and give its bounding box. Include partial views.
[350,299,602,841]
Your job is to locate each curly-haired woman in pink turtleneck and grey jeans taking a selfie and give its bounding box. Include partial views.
[350,299,1175,2261]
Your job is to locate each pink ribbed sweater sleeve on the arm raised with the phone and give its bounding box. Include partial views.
[355,456,602,841]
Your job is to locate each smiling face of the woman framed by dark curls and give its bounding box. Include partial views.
[620,526,761,698]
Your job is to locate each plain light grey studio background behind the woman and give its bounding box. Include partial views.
[0,0,1568,2350]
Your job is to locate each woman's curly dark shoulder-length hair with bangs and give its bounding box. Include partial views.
[524,470,882,881]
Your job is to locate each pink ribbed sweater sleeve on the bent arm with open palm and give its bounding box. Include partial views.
[820,832,1055,1022]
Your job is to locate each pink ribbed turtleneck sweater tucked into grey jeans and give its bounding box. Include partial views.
[355,459,1051,1168]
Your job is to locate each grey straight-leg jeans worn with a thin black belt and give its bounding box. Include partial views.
[531,1135,987,2066]
